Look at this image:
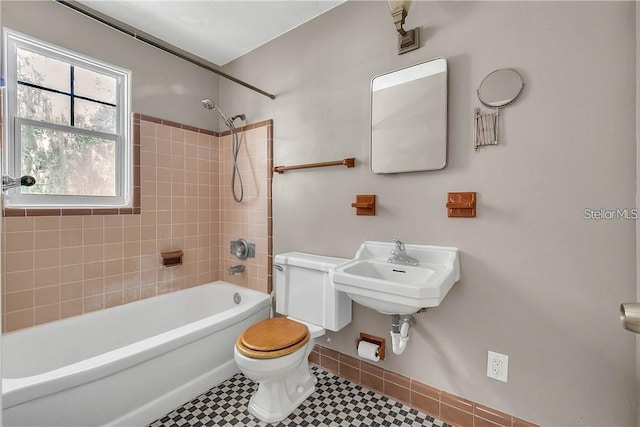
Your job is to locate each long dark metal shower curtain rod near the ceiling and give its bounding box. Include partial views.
[54,0,276,99]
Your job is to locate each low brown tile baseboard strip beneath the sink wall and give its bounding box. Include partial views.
[309,343,536,427]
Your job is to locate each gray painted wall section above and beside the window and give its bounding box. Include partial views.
[0,0,219,130]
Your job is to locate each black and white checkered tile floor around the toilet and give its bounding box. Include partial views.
[149,366,451,427]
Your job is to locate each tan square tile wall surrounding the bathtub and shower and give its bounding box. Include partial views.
[2,115,272,332]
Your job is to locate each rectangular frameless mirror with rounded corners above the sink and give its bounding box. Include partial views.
[369,58,447,174]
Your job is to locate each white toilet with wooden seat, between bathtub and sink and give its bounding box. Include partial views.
[234,252,351,423]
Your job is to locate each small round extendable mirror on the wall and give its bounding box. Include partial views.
[478,68,524,108]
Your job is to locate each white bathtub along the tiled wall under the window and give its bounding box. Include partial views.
[2,281,269,427]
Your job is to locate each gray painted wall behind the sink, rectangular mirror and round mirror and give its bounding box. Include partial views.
[220,1,636,426]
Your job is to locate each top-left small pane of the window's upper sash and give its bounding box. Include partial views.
[17,48,71,93]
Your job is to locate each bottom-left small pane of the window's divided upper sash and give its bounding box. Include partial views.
[17,84,71,125]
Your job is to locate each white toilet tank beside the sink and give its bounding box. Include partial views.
[274,252,351,331]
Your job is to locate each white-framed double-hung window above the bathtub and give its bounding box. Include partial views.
[3,30,132,208]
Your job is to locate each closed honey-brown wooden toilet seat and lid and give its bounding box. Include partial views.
[236,317,309,359]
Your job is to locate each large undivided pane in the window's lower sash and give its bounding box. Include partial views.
[21,125,116,196]
